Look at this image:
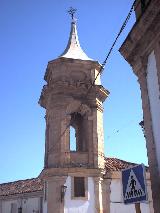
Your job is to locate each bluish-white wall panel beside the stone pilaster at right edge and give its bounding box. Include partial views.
[147,51,160,171]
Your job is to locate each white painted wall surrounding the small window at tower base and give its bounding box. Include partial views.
[64,177,95,213]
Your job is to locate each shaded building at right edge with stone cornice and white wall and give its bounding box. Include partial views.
[120,0,160,213]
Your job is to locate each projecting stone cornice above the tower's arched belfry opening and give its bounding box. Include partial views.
[39,79,109,108]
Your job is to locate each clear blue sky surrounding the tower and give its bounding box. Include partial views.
[0,0,148,182]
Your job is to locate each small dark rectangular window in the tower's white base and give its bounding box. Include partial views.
[74,177,85,197]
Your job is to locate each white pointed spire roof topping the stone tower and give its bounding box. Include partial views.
[59,8,92,60]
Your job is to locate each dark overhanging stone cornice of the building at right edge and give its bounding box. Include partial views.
[119,0,160,73]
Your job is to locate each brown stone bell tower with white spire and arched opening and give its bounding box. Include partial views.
[39,10,109,213]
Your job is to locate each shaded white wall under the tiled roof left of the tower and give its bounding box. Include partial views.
[2,197,40,213]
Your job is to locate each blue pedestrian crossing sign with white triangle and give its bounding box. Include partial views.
[122,164,147,204]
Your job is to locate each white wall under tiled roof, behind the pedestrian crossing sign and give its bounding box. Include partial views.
[110,179,152,213]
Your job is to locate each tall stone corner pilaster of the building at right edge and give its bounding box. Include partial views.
[138,68,160,213]
